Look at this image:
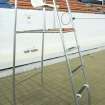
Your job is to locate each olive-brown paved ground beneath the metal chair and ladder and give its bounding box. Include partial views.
[0,51,105,105]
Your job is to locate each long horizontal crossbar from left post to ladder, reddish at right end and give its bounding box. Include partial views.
[16,28,74,34]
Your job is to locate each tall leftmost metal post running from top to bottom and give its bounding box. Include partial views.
[12,0,17,105]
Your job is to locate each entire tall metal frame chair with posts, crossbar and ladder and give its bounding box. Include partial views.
[13,0,91,105]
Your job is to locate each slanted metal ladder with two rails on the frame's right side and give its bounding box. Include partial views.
[53,0,91,105]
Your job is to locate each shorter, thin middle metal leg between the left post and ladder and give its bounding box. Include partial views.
[41,1,46,85]
